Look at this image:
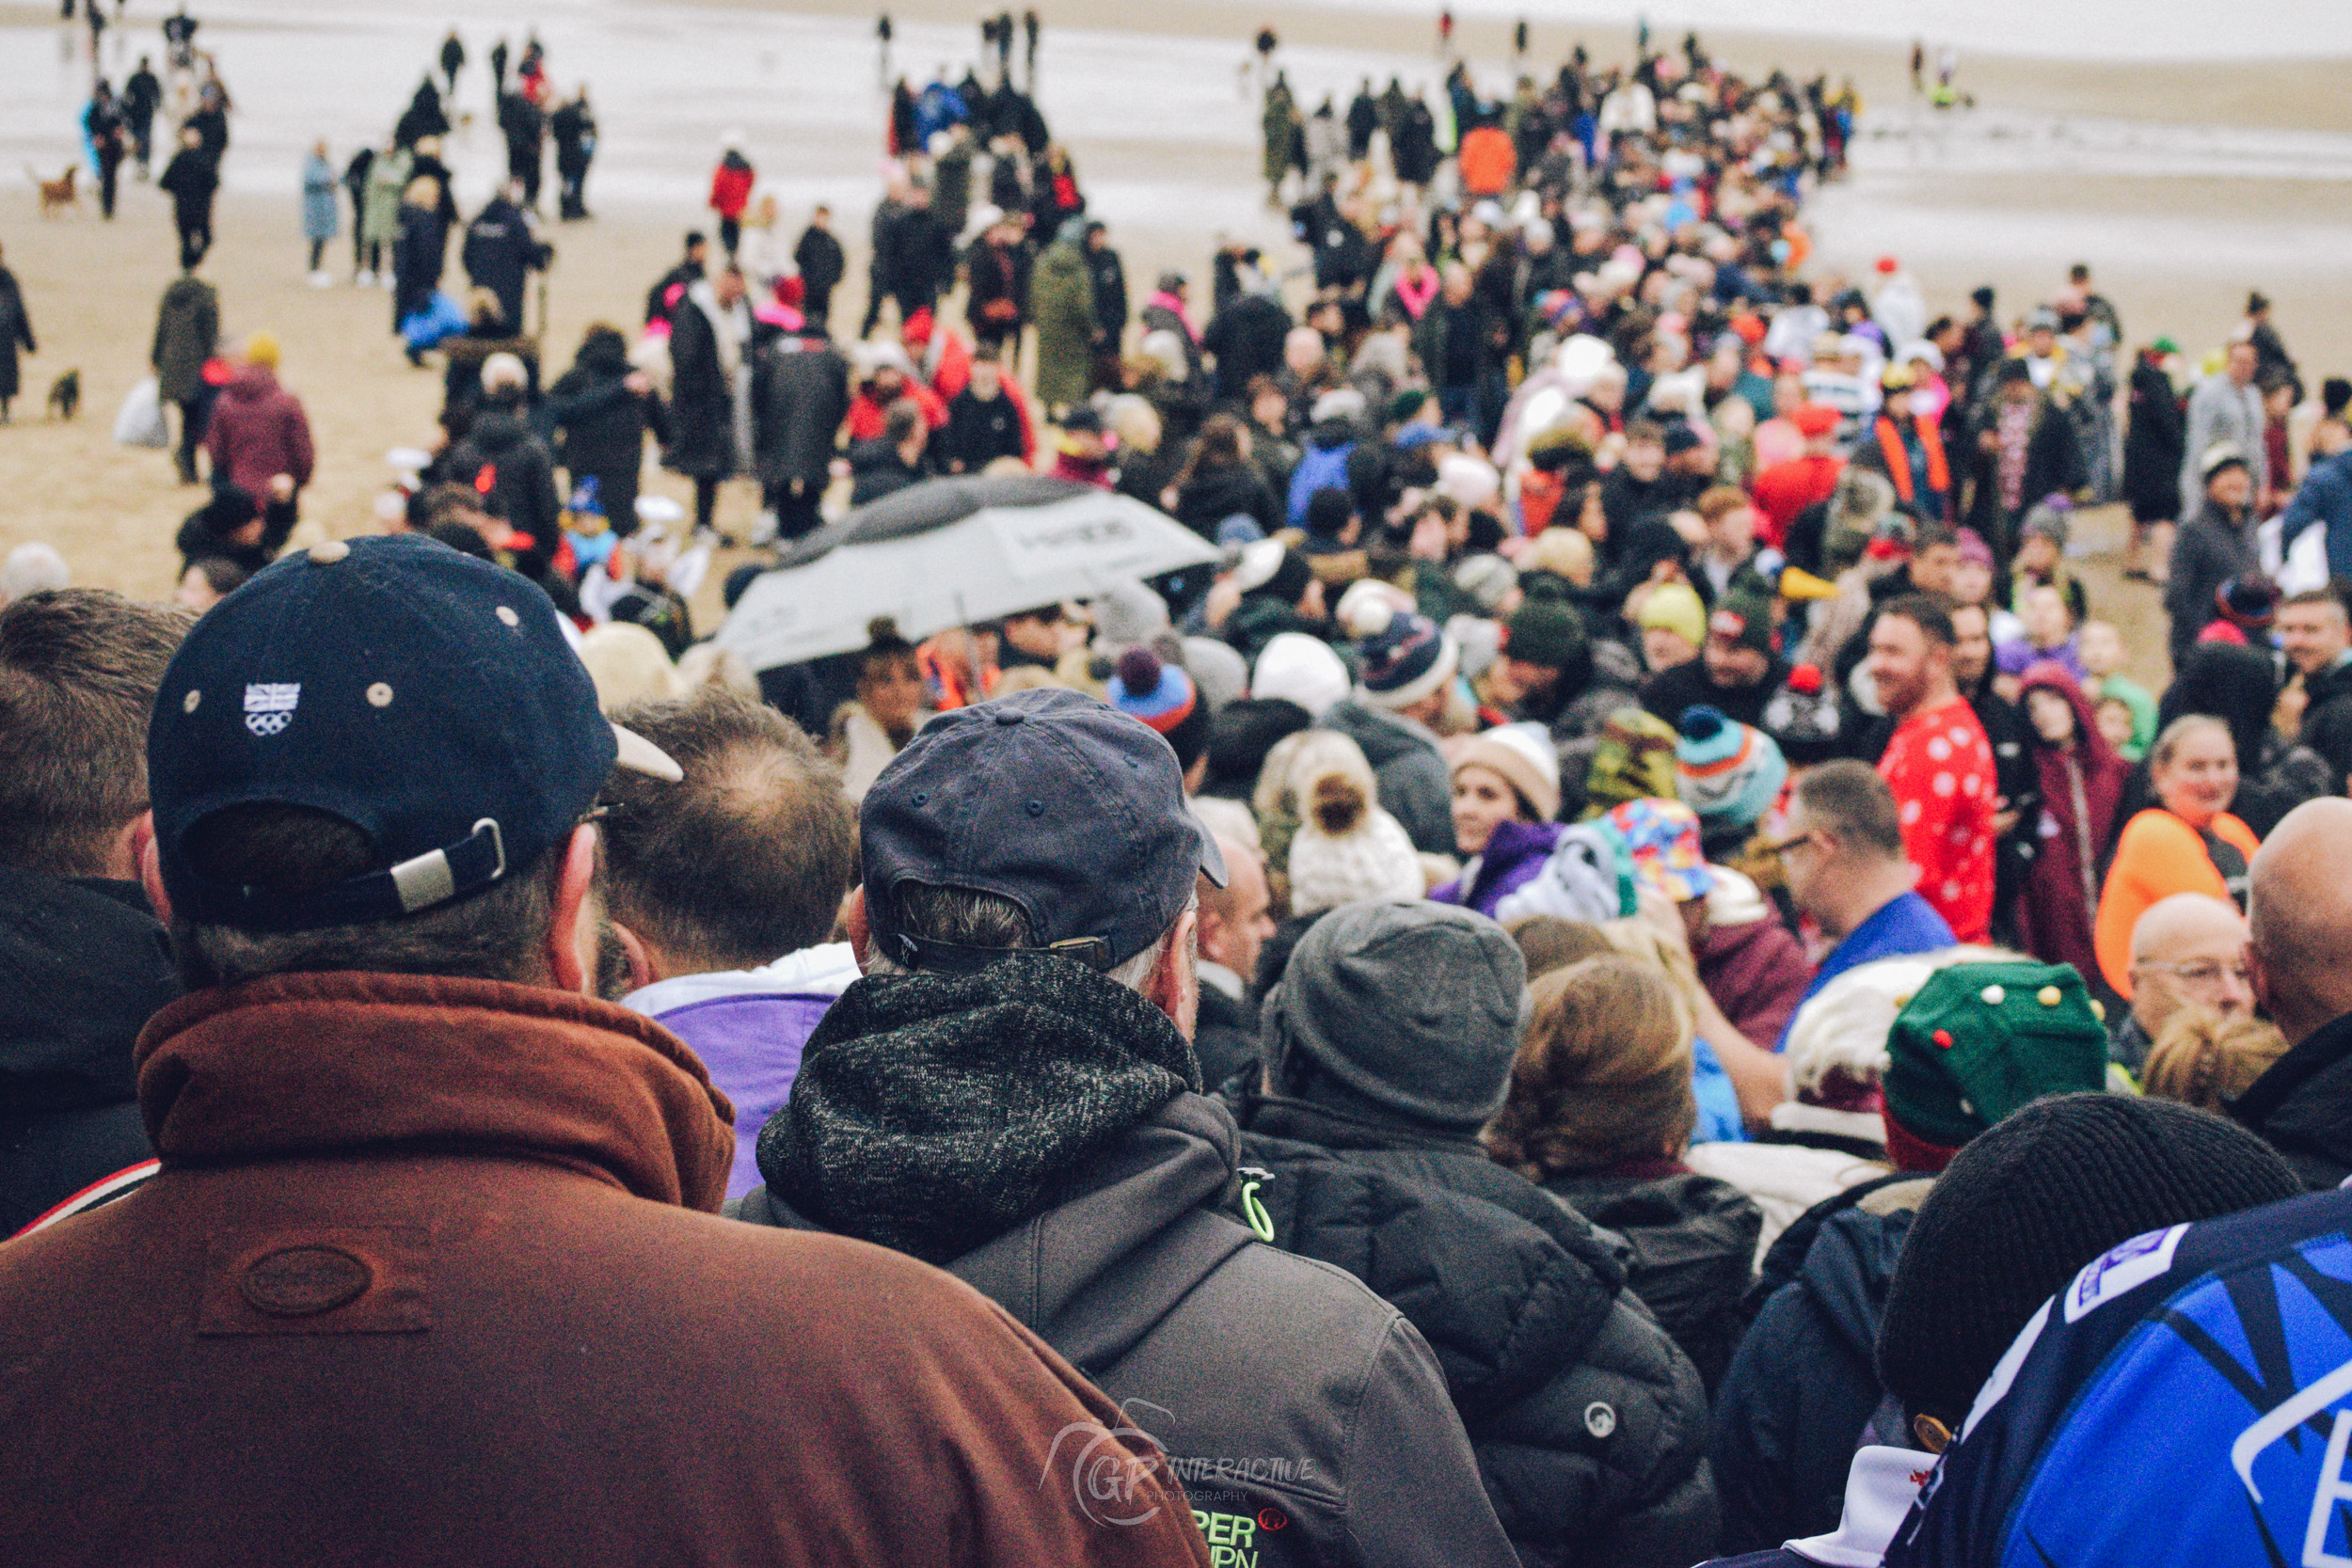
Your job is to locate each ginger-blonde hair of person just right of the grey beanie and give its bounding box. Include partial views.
[1486,952,1698,1182]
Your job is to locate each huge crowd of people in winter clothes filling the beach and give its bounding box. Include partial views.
[18,16,2352,1568]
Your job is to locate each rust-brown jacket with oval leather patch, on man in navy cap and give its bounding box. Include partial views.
[0,974,1209,1568]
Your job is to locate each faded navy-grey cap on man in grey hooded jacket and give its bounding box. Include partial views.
[859,689,1226,974]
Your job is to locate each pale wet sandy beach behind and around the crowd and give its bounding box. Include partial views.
[0,0,2352,681]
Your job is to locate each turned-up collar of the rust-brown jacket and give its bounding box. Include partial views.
[135,974,734,1213]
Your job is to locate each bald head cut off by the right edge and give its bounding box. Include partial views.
[2247,800,2352,1044]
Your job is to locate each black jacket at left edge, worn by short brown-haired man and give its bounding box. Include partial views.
[0,867,179,1242]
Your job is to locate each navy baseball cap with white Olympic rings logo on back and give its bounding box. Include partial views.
[149,533,680,931]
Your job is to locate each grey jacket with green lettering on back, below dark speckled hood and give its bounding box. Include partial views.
[727,1093,1518,1568]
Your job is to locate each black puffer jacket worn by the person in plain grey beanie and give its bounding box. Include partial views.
[1242,1105,1717,1568]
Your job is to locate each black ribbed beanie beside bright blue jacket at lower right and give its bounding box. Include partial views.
[1880,1093,2303,1432]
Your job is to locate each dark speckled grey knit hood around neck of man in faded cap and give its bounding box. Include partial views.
[760,952,1200,1262]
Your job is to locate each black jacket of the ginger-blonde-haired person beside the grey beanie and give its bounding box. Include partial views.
[1543,1171,1764,1394]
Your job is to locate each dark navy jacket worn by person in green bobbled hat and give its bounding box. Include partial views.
[1710,1176,1929,1557]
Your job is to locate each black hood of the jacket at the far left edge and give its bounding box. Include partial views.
[0,867,179,1115]
